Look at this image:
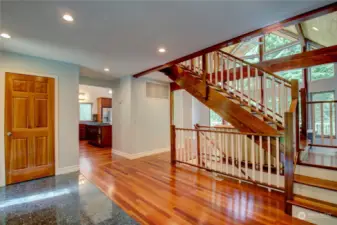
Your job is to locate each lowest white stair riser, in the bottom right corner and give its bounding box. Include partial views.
[292,206,337,225]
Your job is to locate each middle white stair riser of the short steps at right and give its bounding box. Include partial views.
[294,183,337,205]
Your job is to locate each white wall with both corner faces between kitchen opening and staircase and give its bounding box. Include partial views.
[112,76,170,155]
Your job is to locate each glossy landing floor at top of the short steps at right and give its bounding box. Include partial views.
[301,147,337,168]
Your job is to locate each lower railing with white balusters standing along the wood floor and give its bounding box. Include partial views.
[171,125,284,191]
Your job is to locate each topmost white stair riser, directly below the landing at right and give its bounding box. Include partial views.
[295,165,337,181]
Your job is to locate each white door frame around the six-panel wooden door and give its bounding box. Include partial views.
[0,68,59,187]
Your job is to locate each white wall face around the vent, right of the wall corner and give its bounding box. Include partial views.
[132,78,170,153]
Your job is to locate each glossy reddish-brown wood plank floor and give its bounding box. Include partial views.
[80,142,307,225]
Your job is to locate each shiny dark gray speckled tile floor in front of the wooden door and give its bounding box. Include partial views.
[0,173,138,225]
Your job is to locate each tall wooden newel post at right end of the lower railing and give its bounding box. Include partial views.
[284,112,296,215]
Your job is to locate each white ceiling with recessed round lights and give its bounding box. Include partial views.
[0,0,333,79]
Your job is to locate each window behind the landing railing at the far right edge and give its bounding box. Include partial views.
[310,91,336,136]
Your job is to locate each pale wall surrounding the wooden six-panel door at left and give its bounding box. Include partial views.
[0,52,79,186]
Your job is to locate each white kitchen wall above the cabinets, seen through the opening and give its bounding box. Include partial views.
[79,84,112,114]
